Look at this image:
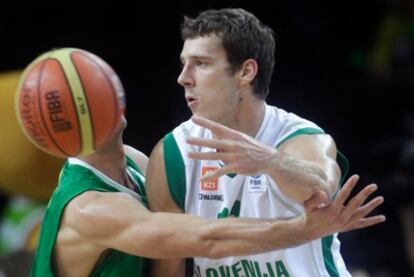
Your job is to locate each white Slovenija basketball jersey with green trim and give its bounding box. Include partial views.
[164,105,350,277]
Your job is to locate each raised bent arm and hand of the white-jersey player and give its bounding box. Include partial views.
[187,117,341,203]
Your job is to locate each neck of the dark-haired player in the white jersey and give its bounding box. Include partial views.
[222,97,266,137]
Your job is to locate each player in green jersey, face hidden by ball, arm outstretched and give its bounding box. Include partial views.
[31,112,383,277]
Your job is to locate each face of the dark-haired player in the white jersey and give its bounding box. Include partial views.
[177,35,239,122]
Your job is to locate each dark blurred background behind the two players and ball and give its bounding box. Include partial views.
[0,0,414,277]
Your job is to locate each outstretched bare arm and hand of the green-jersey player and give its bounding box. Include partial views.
[64,176,385,258]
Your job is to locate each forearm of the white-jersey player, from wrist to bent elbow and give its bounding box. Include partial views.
[264,151,332,203]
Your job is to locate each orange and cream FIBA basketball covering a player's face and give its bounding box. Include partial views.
[15,48,125,157]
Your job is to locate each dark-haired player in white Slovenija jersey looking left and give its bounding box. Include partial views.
[146,9,384,277]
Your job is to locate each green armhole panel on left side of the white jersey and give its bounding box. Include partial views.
[164,133,187,211]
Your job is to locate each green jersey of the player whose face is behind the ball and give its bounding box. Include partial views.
[31,157,147,277]
